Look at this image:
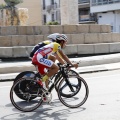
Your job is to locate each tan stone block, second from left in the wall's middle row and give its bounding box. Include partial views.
[12,35,28,46]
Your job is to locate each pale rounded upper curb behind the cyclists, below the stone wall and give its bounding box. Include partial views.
[0,53,120,74]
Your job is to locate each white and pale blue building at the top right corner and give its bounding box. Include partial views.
[90,0,120,33]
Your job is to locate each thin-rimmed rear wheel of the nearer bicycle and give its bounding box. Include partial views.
[10,78,43,112]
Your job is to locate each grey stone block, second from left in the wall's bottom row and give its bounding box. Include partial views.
[13,46,28,57]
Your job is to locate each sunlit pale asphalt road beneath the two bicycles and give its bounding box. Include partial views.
[0,70,120,120]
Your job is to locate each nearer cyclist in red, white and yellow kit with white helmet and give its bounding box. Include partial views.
[32,34,78,89]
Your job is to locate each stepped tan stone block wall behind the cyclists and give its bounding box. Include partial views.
[0,24,120,58]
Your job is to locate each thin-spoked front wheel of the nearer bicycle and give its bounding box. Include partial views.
[58,76,89,108]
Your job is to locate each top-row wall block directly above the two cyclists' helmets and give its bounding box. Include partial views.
[50,25,63,34]
